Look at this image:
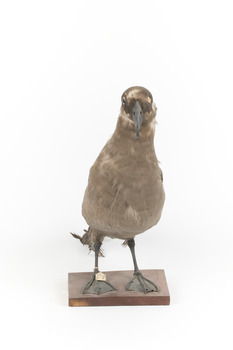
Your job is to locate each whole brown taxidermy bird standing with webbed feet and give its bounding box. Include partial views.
[71,86,165,294]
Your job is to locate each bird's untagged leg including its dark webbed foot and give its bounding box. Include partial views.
[126,239,159,293]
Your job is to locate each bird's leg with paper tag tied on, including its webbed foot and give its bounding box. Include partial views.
[83,243,115,295]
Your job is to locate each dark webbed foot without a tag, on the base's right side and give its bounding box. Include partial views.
[126,272,159,294]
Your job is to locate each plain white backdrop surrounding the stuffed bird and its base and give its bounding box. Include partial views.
[0,0,233,350]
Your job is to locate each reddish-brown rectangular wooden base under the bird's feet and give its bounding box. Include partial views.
[68,270,170,306]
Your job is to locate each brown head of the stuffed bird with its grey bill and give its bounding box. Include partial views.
[121,86,156,138]
